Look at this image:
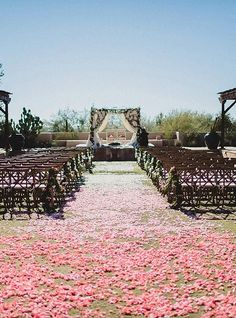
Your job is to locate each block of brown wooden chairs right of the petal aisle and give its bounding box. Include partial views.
[136,147,236,211]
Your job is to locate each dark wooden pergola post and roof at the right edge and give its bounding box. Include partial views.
[218,88,236,149]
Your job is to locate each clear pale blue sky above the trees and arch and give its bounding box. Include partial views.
[0,0,236,119]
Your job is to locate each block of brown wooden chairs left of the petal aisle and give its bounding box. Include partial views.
[0,149,93,218]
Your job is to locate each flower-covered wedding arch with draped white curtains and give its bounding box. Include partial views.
[87,107,140,148]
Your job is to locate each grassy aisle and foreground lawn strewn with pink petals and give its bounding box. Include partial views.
[0,162,236,318]
